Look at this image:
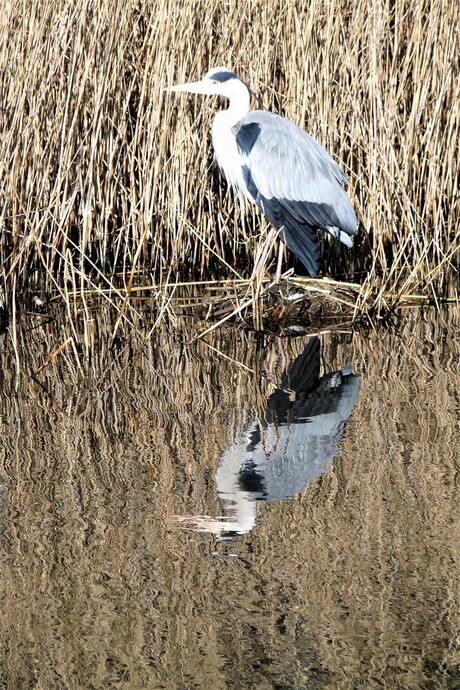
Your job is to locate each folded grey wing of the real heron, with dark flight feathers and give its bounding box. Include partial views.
[235,110,357,276]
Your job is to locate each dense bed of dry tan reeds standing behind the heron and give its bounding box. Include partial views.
[0,0,460,320]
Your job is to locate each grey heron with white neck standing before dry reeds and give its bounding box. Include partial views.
[168,67,358,277]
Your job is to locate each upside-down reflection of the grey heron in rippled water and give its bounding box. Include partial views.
[179,337,359,539]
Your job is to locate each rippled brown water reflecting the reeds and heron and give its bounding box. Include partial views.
[0,310,460,690]
